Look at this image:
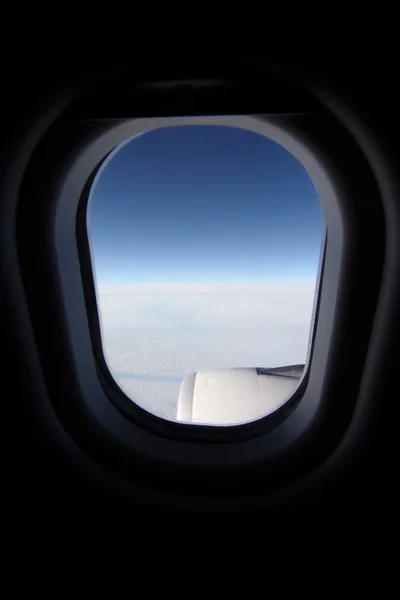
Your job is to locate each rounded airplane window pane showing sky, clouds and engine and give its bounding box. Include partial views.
[87,125,325,425]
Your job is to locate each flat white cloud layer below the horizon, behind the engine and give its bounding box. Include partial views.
[98,282,315,419]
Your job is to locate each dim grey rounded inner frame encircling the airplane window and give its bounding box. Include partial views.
[14,94,379,490]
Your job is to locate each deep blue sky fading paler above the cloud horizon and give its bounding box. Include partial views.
[88,126,323,284]
